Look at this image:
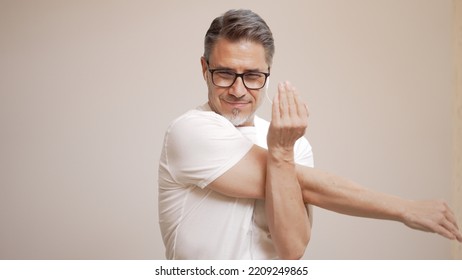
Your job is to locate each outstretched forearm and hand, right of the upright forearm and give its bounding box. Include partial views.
[298,166,462,242]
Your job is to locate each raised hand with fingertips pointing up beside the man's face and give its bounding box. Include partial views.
[267,82,308,150]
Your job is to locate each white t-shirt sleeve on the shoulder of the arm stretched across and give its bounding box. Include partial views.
[164,111,253,188]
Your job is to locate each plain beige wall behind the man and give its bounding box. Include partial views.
[0,0,462,259]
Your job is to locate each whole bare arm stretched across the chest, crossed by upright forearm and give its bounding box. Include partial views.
[210,82,462,245]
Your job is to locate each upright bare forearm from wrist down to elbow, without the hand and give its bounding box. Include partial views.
[265,148,311,259]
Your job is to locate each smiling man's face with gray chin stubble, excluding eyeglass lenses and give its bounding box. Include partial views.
[201,39,269,126]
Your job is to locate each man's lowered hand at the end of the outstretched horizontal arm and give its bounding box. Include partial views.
[403,200,462,242]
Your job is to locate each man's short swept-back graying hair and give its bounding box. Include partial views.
[204,10,274,66]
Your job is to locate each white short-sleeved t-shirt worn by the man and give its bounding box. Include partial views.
[158,105,313,259]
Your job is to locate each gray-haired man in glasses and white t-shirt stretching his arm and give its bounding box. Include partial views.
[159,10,462,259]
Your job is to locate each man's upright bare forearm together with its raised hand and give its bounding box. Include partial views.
[265,83,311,259]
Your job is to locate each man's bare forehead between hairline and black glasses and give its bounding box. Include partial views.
[209,39,268,71]
